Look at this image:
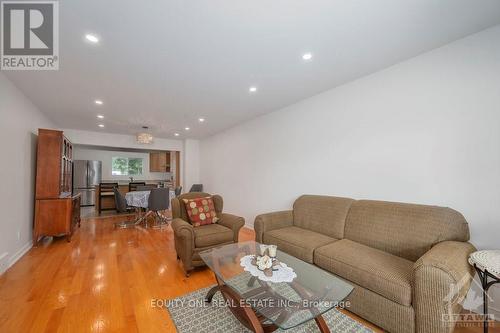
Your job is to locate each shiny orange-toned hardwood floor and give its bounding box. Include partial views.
[0,216,492,333]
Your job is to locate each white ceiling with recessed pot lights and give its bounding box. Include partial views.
[5,0,500,138]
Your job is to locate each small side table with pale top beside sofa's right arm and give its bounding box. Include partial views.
[469,250,500,333]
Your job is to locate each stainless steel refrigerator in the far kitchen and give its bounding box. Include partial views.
[73,160,102,206]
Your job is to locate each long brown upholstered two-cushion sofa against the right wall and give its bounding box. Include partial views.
[254,195,475,333]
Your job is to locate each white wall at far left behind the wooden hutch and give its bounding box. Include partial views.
[0,73,55,274]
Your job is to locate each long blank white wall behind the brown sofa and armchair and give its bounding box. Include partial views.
[200,26,500,248]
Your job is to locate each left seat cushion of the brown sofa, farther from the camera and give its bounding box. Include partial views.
[263,227,337,264]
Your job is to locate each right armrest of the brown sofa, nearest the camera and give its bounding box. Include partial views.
[413,241,476,333]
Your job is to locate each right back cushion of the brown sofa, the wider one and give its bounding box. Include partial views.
[345,200,469,261]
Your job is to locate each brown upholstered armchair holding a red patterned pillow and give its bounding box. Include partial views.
[172,192,245,276]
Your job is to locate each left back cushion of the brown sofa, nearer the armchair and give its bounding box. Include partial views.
[293,195,354,239]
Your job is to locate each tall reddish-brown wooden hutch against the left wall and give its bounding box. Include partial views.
[33,129,80,245]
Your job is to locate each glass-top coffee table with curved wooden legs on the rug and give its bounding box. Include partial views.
[200,242,354,332]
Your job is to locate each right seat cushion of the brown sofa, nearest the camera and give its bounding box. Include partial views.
[314,239,414,306]
